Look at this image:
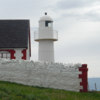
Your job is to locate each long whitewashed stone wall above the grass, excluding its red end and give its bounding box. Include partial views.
[0,60,82,91]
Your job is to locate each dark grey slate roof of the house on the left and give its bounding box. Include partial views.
[0,20,30,48]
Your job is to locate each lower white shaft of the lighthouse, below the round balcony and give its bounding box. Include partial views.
[38,40,54,62]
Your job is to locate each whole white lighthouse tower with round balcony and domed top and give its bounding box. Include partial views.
[34,13,58,62]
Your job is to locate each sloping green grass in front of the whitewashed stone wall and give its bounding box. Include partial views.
[0,81,100,100]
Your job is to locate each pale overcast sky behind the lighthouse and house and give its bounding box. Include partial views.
[0,0,100,77]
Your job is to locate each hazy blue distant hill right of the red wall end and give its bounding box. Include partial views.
[88,78,100,91]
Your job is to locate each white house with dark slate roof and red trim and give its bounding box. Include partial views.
[0,20,31,60]
